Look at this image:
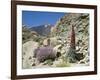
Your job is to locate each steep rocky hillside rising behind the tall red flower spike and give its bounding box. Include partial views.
[52,13,89,61]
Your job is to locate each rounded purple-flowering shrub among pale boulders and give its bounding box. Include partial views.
[36,46,56,62]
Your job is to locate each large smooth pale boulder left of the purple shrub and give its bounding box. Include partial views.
[22,41,39,68]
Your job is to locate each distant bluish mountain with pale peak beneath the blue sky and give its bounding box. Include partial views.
[30,24,53,36]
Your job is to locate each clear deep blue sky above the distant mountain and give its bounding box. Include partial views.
[22,11,65,27]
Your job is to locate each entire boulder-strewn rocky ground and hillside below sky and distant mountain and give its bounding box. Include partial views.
[23,13,89,68]
